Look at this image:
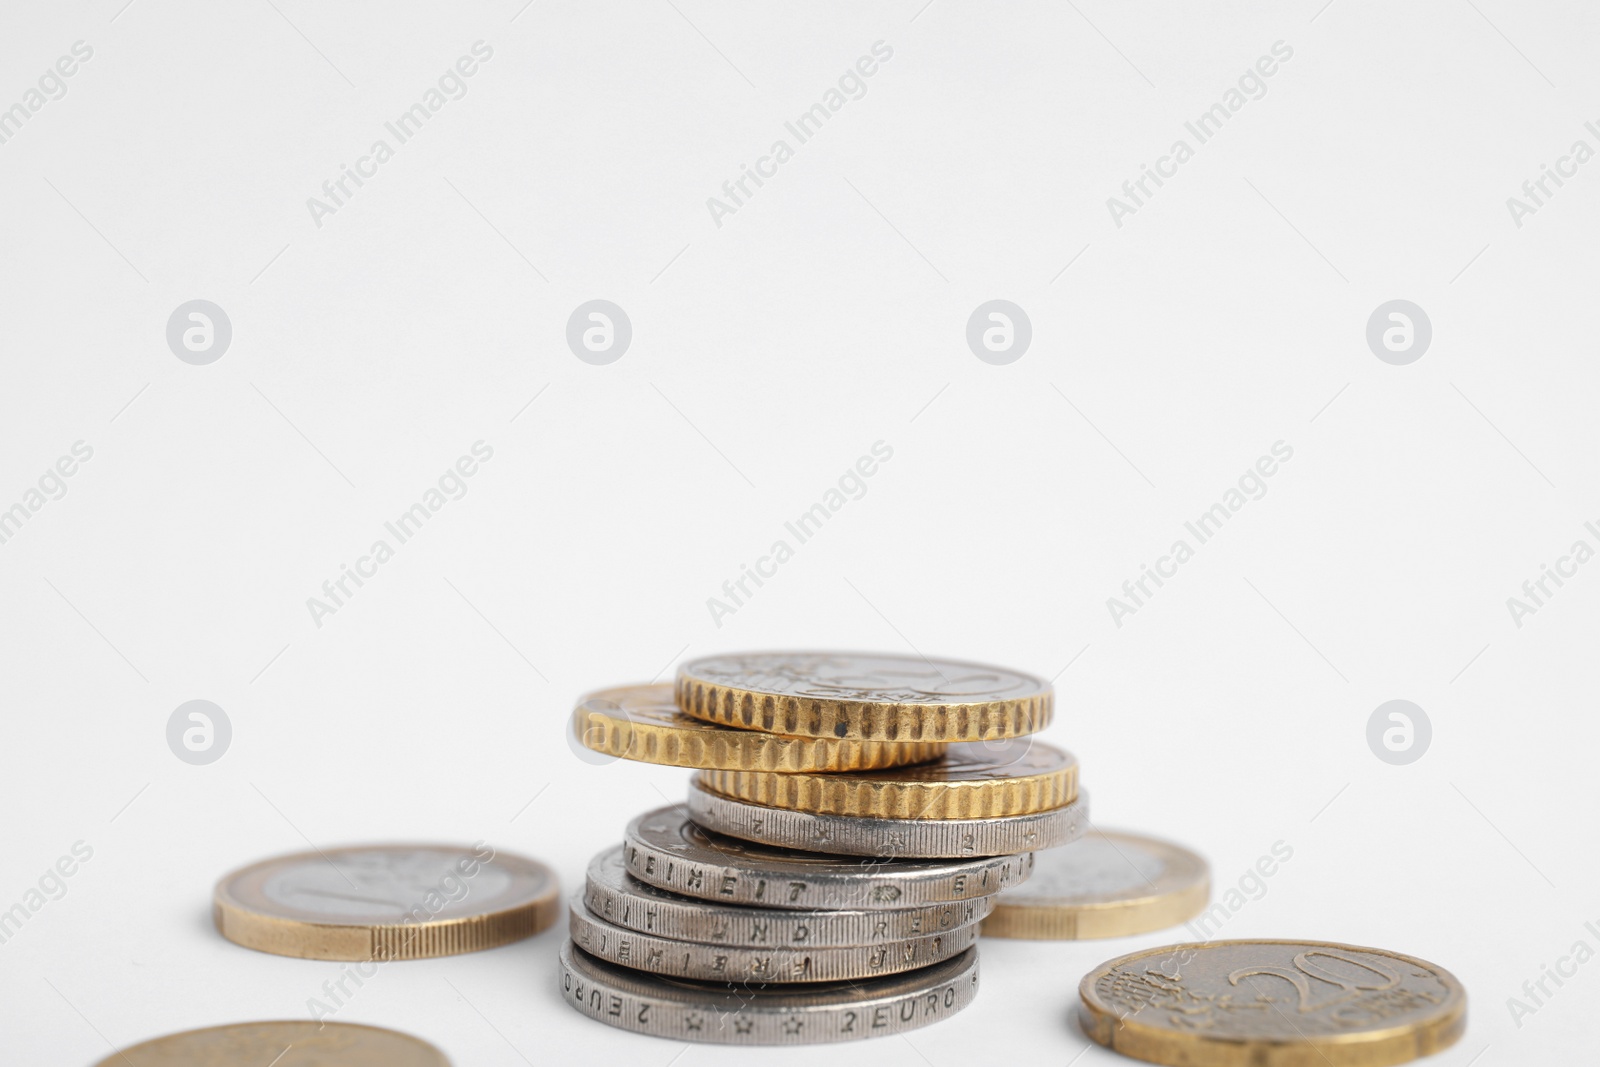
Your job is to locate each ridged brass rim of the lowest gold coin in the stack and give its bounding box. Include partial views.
[696,741,1078,821]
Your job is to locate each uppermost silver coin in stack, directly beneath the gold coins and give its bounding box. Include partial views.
[690,781,1090,859]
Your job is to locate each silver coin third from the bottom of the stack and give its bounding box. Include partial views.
[584,846,995,949]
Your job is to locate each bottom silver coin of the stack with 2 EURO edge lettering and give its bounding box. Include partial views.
[560,942,978,1045]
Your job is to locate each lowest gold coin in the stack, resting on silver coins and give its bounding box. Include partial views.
[699,739,1078,819]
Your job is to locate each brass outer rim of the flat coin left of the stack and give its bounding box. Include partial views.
[211,841,562,963]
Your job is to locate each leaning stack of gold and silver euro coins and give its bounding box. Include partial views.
[562,653,1088,1045]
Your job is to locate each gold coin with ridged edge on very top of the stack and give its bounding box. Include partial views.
[677,653,1054,742]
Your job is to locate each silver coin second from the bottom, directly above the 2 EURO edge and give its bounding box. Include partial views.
[566,896,978,982]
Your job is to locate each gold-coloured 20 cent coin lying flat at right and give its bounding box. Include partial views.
[1078,941,1467,1067]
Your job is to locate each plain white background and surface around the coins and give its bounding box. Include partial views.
[0,0,1600,1067]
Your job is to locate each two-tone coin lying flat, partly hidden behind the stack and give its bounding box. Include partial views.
[984,830,1211,941]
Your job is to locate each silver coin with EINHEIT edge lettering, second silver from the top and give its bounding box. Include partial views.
[624,806,1034,910]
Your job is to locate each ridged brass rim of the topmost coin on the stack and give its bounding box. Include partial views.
[675,649,1056,742]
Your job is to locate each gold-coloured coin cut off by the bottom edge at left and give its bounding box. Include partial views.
[94,1019,450,1067]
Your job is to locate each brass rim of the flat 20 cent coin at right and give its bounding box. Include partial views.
[1078,937,1467,1067]
